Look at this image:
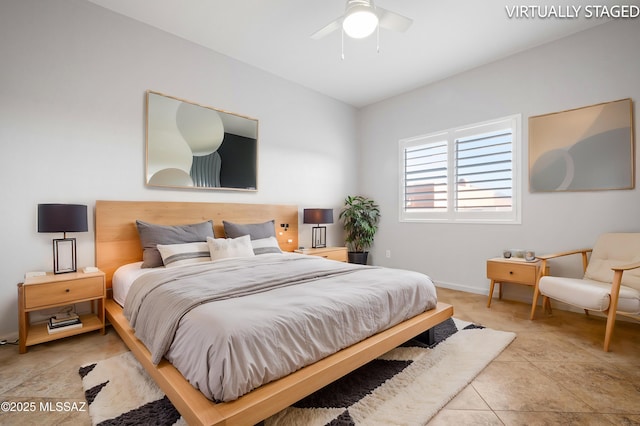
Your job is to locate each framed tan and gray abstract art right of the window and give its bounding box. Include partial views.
[529,98,635,192]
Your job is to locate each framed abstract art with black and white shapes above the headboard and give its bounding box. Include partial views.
[145,90,258,191]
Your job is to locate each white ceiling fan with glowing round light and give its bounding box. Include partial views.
[311,0,413,40]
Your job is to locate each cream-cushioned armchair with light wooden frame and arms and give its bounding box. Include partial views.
[531,233,640,352]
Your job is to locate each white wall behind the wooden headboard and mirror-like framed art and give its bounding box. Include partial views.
[0,0,357,338]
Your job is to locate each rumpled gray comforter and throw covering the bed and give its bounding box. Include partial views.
[124,254,436,401]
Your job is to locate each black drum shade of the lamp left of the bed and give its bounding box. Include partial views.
[38,204,88,232]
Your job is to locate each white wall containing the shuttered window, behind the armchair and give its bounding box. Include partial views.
[359,19,640,301]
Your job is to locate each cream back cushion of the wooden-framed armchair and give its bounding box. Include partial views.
[584,233,640,290]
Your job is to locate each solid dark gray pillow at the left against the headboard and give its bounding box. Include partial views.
[136,220,213,268]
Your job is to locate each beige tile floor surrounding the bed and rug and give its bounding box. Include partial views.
[0,289,640,426]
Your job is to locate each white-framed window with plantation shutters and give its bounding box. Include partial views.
[400,115,520,223]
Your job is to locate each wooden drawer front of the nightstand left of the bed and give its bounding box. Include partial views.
[24,276,104,309]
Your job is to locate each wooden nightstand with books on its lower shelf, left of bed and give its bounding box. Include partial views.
[18,271,107,354]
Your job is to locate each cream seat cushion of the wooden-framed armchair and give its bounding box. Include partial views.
[538,276,640,314]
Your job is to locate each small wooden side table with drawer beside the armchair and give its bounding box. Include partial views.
[487,257,548,308]
